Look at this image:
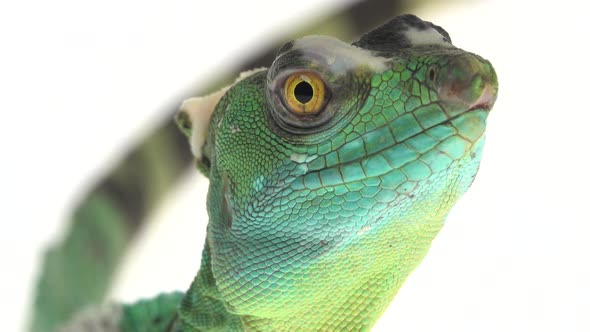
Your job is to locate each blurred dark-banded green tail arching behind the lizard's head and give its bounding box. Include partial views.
[29,0,412,332]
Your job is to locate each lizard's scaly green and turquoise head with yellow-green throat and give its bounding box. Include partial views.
[178,15,498,330]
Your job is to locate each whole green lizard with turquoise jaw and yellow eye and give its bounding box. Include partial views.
[32,11,498,331]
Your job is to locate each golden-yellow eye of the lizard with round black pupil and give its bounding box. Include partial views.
[283,71,328,115]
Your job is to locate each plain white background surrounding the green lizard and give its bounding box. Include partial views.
[0,0,590,331]
